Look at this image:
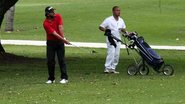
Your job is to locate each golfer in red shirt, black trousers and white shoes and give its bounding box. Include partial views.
[43,6,70,84]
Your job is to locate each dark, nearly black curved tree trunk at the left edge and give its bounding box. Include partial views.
[0,0,18,53]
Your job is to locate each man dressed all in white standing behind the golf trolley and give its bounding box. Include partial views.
[99,6,126,73]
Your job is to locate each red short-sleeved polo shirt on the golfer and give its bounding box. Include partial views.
[43,14,63,41]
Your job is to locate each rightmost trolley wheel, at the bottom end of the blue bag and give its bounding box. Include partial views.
[162,65,174,76]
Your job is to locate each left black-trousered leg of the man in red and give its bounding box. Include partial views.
[47,43,55,81]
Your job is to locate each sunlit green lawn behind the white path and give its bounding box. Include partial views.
[0,0,185,45]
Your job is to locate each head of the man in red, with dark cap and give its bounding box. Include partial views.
[45,6,55,18]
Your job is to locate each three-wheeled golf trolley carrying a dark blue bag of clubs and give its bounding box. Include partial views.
[106,32,174,76]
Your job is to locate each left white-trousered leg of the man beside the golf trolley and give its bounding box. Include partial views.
[105,43,115,70]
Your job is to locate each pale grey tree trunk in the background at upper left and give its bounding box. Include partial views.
[5,5,15,32]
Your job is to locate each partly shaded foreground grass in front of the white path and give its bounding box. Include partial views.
[0,46,185,104]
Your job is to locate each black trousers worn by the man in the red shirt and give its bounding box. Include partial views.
[47,40,68,81]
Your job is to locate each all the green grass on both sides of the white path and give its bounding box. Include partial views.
[0,0,185,104]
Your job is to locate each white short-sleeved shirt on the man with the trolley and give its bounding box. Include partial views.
[100,16,126,39]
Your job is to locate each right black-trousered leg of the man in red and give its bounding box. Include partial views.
[57,43,68,80]
